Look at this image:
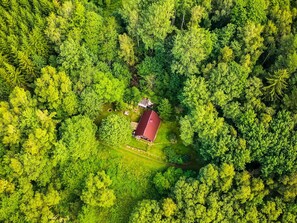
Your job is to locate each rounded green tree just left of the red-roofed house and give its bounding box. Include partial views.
[99,114,132,146]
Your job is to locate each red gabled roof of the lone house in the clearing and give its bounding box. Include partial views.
[135,110,161,141]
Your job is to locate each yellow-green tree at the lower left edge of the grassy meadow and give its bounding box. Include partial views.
[81,171,116,208]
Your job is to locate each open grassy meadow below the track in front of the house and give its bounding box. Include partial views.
[98,148,167,223]
